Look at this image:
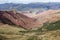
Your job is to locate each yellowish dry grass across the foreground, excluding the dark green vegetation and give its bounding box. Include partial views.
[0,25,60,40]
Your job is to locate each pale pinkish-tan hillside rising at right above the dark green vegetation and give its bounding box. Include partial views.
[35,10,60,25]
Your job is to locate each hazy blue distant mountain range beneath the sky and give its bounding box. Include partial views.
[0,2,60,11]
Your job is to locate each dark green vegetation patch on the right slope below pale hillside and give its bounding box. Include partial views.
[40,21,60,31]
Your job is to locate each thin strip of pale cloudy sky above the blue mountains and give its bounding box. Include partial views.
[0,0,60,4]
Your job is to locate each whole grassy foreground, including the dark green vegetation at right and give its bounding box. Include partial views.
[0,11,60,40]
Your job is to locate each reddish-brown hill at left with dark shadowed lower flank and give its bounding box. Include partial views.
[0,11,36,29]
